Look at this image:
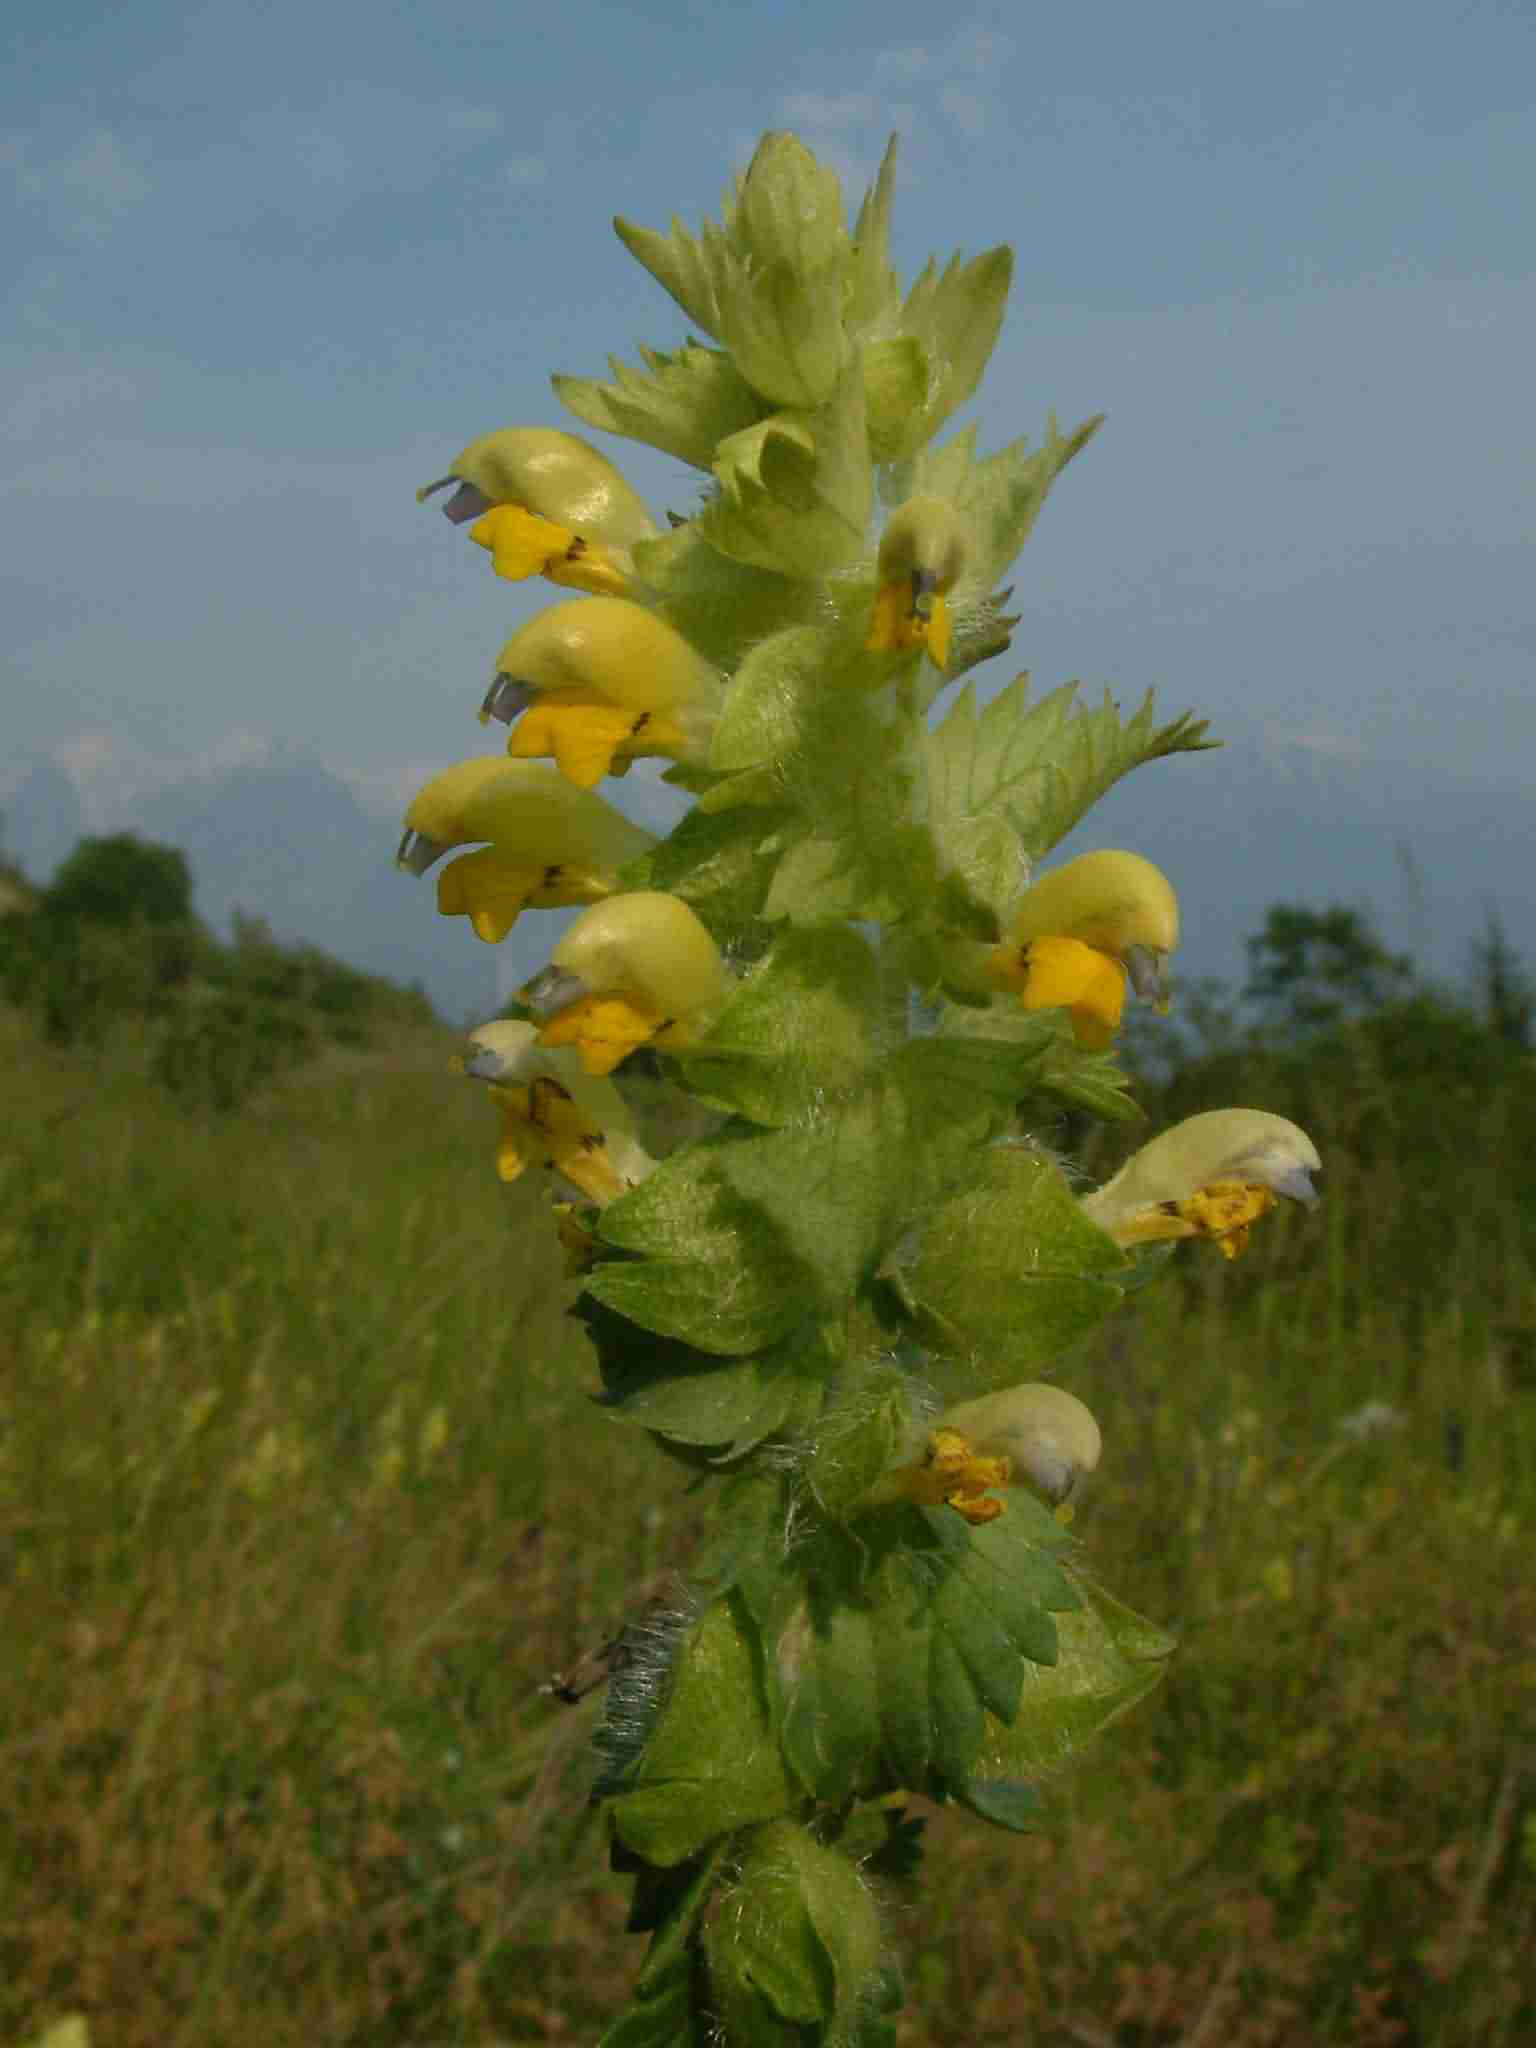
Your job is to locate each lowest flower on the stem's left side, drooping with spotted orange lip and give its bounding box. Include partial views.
[459,1018,655,1206]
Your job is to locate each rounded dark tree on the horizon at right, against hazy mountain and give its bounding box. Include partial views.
[1243,903,1413,1032]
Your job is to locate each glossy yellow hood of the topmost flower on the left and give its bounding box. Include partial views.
[416,426,657,552]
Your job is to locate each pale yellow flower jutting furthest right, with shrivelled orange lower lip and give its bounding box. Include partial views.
[1081,1110,1321,1260]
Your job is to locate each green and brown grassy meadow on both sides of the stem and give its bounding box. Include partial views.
[0,978,1536,2048]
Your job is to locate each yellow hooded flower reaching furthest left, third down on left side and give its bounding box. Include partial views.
[397,756,655,944]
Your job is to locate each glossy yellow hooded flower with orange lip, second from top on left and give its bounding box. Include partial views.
[481,596,719,788]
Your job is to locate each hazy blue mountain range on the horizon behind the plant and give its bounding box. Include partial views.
[0,727,1536,1022]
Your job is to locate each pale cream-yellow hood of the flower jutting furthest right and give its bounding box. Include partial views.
[1081,1110,1321,1241]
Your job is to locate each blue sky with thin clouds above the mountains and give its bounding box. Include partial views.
[0,0,1536,839]
